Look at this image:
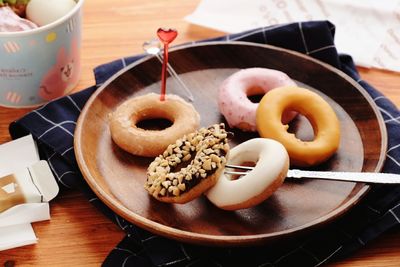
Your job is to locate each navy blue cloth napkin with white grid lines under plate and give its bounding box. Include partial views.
[10,21,400,266]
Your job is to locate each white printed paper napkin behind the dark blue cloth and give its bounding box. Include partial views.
[185,0,400,71]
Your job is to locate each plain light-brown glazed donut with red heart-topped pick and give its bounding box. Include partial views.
[110,93,200,157]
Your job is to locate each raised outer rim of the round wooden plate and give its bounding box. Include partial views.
[74,41,388,245]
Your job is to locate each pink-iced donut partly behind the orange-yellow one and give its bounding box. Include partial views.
[218,68,296,132]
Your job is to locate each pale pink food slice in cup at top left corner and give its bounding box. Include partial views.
[0,6,38,32]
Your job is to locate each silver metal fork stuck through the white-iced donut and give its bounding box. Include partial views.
[224,164,400,184]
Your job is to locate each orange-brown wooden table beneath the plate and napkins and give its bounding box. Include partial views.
[0,0,400,267]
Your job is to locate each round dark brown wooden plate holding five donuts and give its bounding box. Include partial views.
[75,42,387,245]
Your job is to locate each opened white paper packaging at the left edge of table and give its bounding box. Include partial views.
[0,135,59,250]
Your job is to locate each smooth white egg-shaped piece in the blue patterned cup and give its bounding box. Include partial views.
[26,0,76,26]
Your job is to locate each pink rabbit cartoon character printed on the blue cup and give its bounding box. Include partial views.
[39,38,80,100]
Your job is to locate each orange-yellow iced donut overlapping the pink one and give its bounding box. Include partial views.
[257,87,340,167]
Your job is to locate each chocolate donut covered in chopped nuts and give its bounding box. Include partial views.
[144,124,229,204]
